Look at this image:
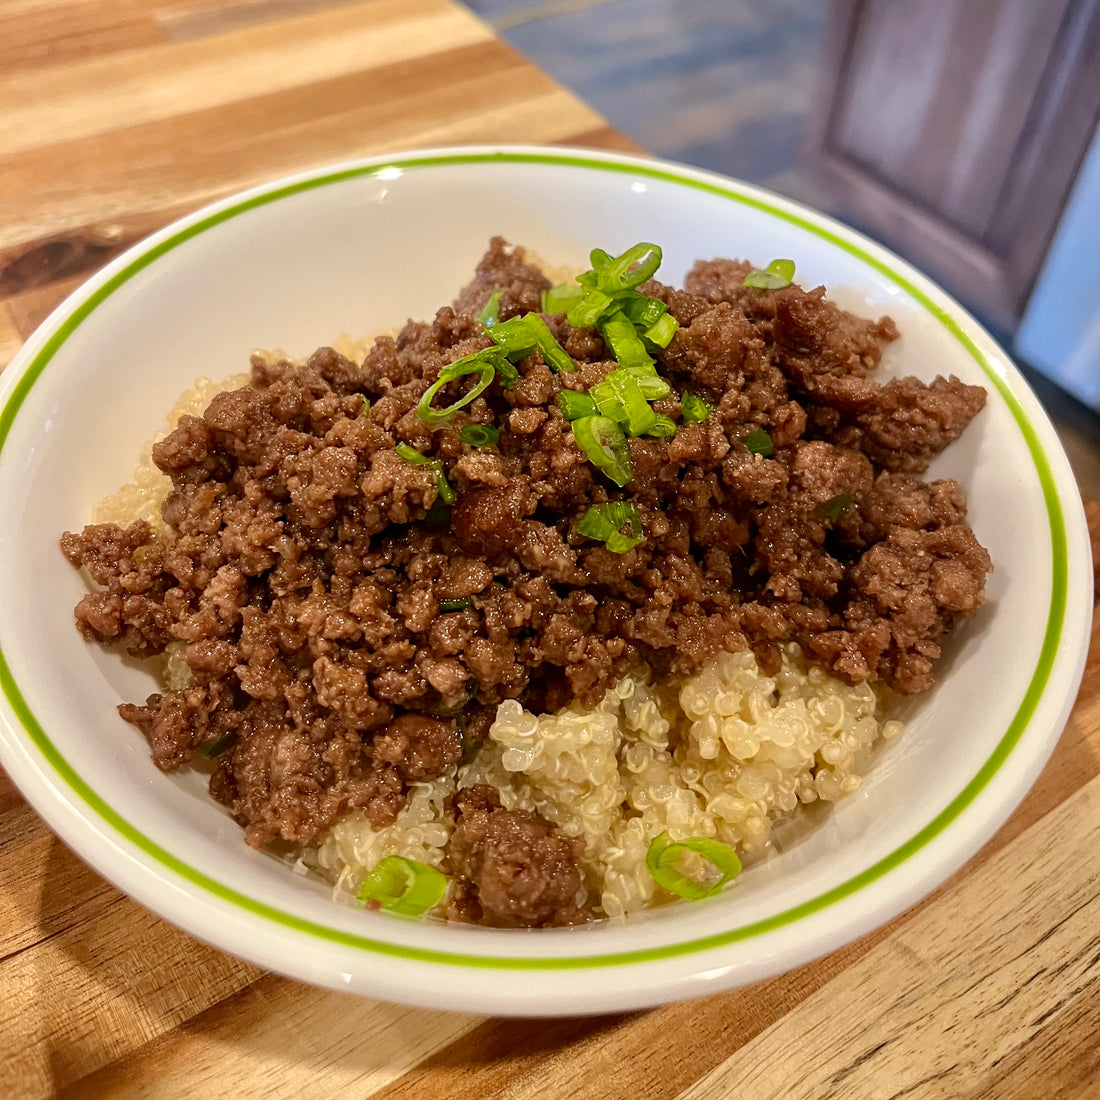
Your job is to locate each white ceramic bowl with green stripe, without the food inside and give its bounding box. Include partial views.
[0,149,1091,1015]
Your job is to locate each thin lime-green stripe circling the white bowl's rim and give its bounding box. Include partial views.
[0,152,1068,970]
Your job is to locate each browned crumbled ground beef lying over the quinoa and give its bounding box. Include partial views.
[62,239,991,924]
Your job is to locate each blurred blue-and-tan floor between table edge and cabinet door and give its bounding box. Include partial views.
[455,0,827,197]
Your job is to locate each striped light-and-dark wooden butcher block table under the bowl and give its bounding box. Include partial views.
[0,0,1100,1100]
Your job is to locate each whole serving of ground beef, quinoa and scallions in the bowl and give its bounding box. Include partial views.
[62,239,991,926]
